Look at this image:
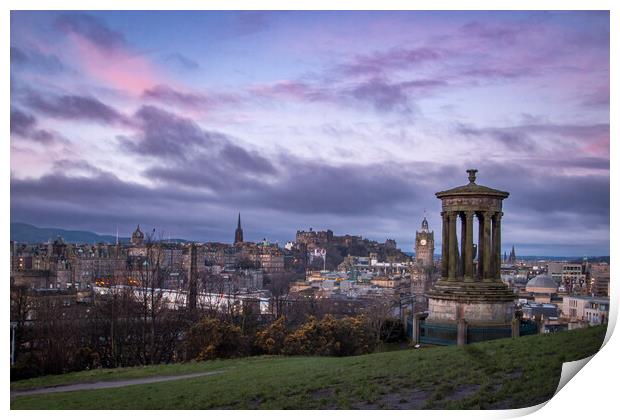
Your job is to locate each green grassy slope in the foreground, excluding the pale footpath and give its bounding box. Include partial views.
[11,327,605,409]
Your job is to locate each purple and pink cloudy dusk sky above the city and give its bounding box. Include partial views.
[10,11,610,257]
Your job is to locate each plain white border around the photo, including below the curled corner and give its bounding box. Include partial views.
[0,0,620,419]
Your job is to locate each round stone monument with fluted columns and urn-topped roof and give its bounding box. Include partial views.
[425,169,518,344]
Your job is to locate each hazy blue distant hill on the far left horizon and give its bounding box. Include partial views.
[11,222,129,244]
